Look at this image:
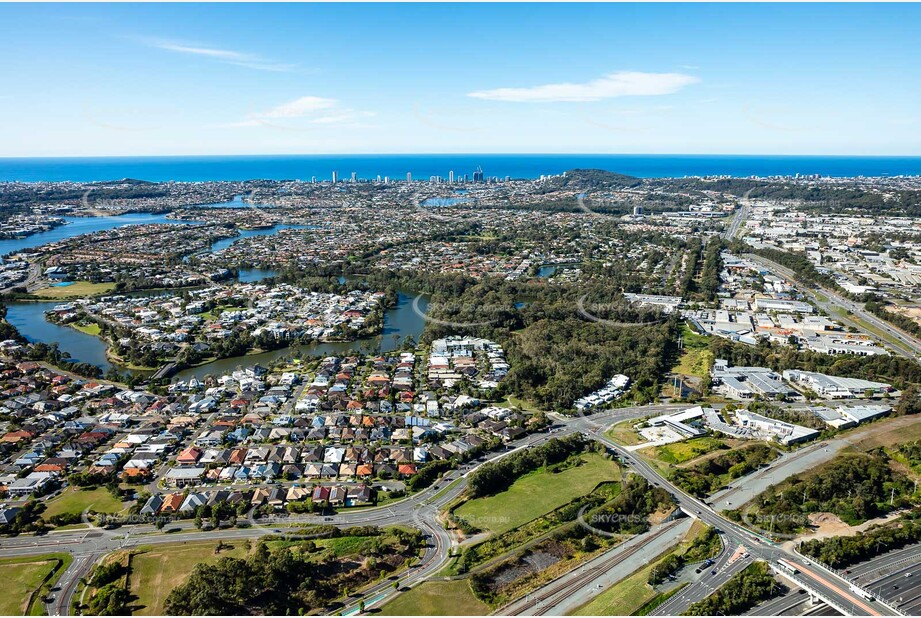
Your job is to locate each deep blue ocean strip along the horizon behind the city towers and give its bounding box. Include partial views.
[0,154,921,182]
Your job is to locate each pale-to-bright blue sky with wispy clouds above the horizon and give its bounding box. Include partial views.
[0,4,921,156]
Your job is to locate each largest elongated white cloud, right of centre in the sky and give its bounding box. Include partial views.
[467,71,700,103]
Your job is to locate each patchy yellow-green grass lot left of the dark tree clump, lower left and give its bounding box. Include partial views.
[128,541,246,616]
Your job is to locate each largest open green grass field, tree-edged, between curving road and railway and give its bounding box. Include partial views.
[455,453,621,534]
